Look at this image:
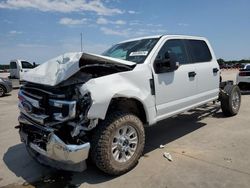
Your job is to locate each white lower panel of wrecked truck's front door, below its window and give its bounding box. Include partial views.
[155,64,196,116]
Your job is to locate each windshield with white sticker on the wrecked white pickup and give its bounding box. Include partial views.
[102,38,159,63]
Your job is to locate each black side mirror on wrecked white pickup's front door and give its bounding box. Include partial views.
[154,52,179,74]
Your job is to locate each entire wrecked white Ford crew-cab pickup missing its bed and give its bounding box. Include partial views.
[16,35,241,175]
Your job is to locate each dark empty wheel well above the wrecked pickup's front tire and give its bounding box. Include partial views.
[107,97,147,124]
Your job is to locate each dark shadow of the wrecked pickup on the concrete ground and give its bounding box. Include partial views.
[3,105,224,188]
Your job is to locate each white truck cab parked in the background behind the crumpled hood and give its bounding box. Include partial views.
[10,59,34,80]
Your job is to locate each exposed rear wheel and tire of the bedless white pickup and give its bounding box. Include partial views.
[221,85,241,116]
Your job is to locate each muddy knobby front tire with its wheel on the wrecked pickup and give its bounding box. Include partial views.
[91,112,145,175]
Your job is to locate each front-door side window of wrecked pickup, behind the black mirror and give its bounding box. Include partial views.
[156,39,188,65]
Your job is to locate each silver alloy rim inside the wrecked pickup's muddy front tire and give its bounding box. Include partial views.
[111,125,138,162]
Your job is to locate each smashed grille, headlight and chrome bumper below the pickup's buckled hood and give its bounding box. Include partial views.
[18,81,94,171]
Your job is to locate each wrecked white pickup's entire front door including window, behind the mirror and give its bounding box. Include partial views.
[154,39,197,120]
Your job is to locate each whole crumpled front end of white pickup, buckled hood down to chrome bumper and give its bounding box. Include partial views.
[18,50,138,171]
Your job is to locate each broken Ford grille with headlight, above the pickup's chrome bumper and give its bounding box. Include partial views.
[18,86,76,125]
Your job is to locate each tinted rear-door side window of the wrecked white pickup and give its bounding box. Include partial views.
[186,40,212,63]
